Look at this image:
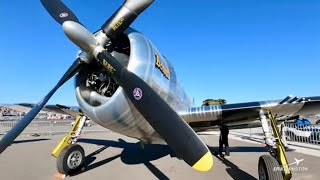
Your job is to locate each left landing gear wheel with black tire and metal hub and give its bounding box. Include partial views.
[57,144,84,175]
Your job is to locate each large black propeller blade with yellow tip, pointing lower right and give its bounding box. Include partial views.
[97,50,213,171]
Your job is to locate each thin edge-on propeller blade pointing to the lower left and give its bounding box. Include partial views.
[0,58,83,154]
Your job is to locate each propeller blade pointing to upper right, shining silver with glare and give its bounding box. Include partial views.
[101,0,154,39]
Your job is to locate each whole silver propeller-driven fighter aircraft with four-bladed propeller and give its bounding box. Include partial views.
[0,0,320,177]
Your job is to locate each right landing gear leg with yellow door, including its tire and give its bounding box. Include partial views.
[258,110,292,180]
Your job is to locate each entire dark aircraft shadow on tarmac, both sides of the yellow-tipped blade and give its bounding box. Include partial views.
[71,138,266,179]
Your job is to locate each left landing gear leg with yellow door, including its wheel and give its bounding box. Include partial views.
[51,113,87,175]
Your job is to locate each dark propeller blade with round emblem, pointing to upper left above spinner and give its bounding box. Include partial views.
[41,0,80,25]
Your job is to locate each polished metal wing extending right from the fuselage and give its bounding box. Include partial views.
[179,96,320,131]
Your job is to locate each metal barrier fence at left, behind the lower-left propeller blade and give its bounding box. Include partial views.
[0,120,107,135]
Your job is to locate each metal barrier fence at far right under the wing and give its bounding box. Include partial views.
[282,123,320,144]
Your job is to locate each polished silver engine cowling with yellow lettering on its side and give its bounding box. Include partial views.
[76,28,191,142]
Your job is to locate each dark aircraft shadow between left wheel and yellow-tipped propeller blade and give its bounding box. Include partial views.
[70,138,174,179]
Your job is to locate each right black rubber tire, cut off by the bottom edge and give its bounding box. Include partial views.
[258,155,283,180]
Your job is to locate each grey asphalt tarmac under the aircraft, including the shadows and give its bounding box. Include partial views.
[0,132,320,180]
